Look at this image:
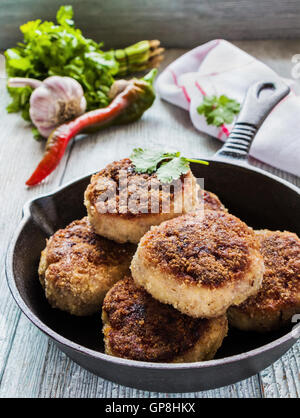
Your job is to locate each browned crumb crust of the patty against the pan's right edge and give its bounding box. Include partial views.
[235,230,300,314]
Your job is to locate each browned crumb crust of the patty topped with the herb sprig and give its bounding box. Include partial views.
[85,158,191,218]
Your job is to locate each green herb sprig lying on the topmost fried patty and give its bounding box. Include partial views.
[130,148,209,183]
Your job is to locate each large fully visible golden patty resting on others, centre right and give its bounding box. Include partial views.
[131,210,264,318]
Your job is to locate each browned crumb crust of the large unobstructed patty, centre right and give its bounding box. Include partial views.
[140,210,258,288]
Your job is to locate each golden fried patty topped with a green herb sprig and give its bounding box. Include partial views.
[84,158,199,243]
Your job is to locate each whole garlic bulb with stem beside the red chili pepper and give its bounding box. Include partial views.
[8,76,86,137]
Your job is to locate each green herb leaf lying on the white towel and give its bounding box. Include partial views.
[197,95,241,127]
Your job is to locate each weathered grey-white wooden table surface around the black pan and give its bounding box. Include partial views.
[0,41,300,398]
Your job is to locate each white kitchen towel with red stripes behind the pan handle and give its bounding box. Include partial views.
[156,40,300,176]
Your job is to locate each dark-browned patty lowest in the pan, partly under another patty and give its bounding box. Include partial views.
[102,277,227,362]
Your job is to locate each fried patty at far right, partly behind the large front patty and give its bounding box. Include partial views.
[229,230,300,332]
